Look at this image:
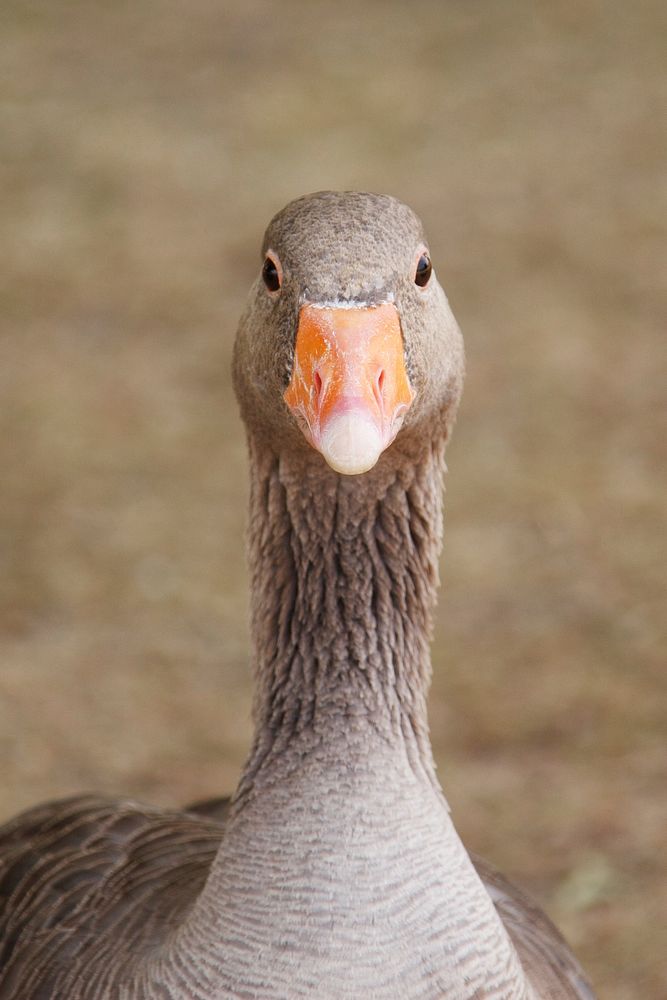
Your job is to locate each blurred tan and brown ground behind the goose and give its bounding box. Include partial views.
[0,0,667,1000]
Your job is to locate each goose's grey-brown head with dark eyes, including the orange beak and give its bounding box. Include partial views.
[234,191,464,475]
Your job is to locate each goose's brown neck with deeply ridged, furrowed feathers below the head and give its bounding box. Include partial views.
[237,437,444,802]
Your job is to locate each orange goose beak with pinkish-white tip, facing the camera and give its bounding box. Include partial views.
[284,302,414,476]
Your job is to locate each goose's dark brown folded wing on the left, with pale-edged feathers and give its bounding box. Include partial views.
[0,796,222,1000]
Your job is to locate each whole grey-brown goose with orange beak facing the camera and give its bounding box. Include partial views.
[0,192,593,1000]
